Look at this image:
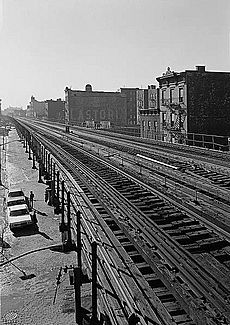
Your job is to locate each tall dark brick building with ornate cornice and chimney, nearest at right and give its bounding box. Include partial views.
[156,66,230,143]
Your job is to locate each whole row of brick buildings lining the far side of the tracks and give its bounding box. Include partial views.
[4,66,230,144]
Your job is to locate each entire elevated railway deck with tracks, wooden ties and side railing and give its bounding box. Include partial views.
[11,120,230,325]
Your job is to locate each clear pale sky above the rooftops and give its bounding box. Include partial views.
[0,0,230,109]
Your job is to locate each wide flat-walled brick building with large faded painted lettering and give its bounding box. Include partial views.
[65,84,127,127]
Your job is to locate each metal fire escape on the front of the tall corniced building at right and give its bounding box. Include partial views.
[162,98,187,143]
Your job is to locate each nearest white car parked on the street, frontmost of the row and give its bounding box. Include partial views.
[7,204,34,230]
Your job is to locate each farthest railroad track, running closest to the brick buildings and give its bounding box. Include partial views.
[18,117,230,195]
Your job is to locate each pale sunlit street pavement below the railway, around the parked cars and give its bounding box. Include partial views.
[0,129,91,325]
